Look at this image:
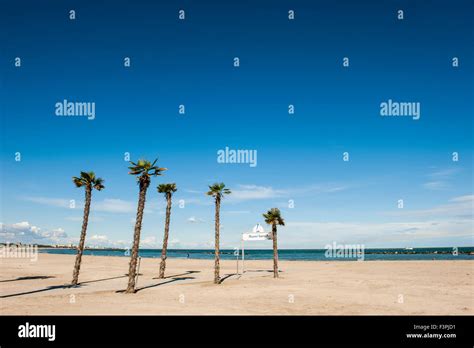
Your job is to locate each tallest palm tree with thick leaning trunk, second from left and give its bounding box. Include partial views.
[125,159,166,293]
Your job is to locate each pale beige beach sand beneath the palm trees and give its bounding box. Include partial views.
[0,254,474,315]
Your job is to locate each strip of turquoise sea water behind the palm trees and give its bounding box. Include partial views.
[40,247,474,261]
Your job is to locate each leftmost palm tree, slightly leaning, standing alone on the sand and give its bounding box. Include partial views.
[71,172,105,286]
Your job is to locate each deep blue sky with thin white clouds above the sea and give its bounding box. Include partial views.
[0,1,474,248]
